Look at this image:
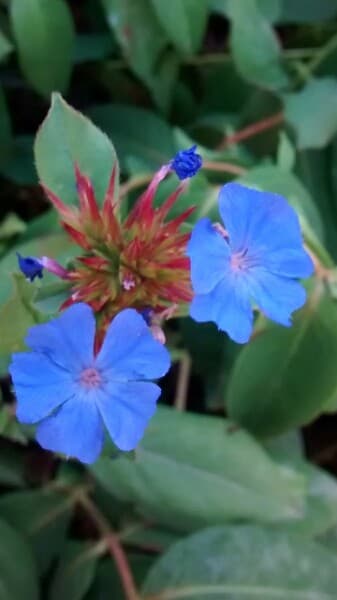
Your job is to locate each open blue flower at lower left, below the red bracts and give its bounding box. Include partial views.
[10,303,170,463]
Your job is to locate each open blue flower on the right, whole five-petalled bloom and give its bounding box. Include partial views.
[187,183,313,343]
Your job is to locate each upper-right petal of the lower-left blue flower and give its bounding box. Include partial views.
[96,308,170,380]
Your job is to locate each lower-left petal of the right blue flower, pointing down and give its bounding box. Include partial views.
[190,276,253,344]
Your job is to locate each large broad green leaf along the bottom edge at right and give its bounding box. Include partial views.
[142,525,337,600]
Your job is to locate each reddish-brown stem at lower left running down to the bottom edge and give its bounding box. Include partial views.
[78,494,140,600]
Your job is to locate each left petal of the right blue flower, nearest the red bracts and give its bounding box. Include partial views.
[187,218,230,294]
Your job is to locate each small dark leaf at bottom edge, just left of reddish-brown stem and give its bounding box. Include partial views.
[48,541,102,600]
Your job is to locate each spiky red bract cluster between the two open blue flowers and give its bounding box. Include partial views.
[45,166,194,331]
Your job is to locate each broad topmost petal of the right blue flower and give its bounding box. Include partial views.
[219,183,303,256]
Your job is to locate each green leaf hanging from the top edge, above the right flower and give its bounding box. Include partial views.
[228,0,288,90]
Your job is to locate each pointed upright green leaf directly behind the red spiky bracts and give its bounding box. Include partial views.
[34,94,118,204]
